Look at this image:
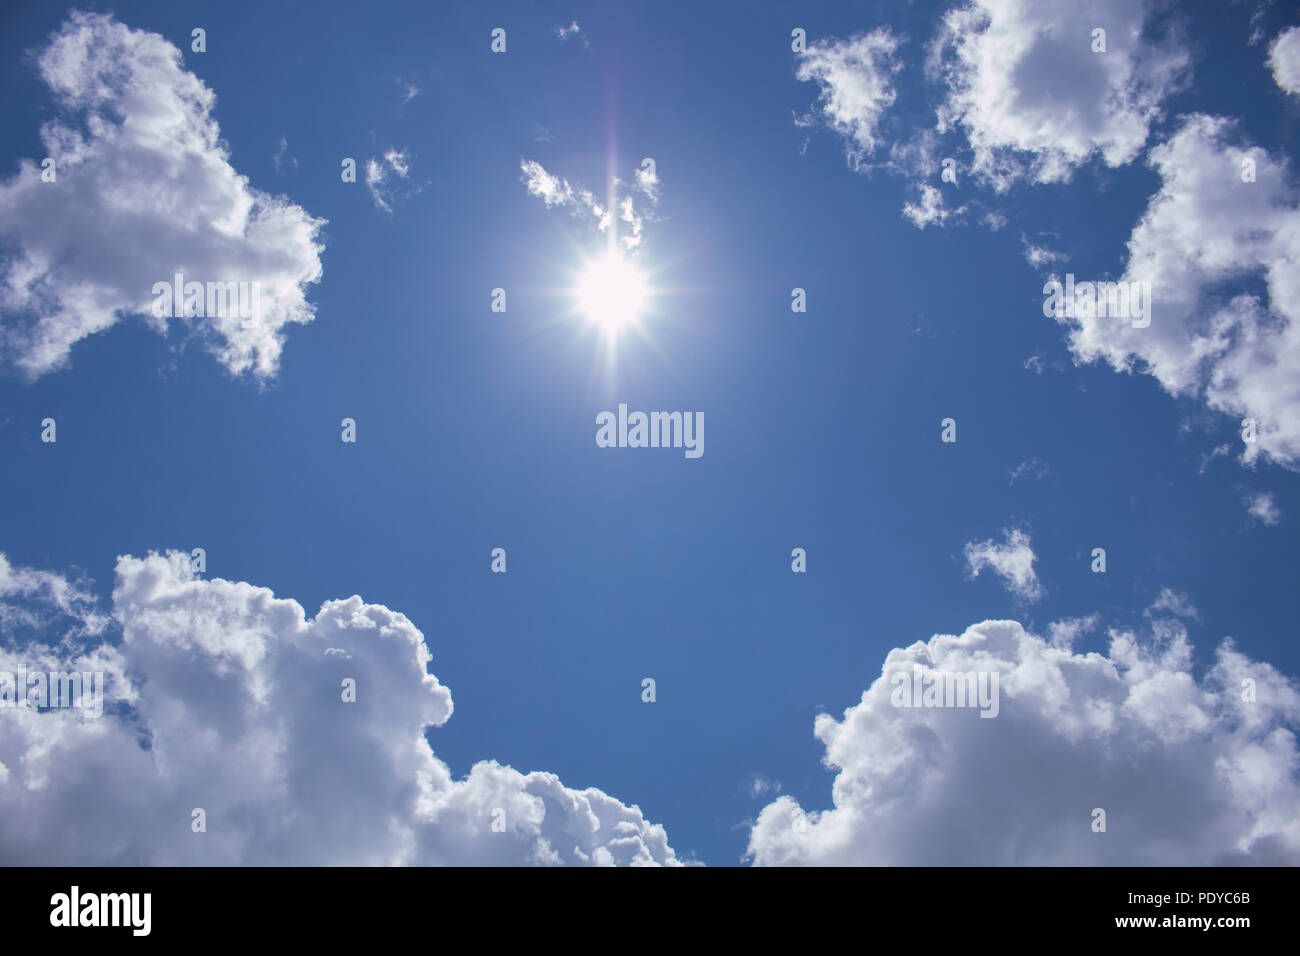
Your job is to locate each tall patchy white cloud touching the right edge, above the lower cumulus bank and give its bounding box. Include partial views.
[1060,114,1300,468]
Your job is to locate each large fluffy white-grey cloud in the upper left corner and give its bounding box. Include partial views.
[0,13,324,377]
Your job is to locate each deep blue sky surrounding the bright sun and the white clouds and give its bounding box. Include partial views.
[0,3,1300,865]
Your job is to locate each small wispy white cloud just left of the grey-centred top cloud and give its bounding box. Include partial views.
[796,27,902,172]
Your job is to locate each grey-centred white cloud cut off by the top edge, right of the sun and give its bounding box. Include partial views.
[927,0,1188,191]
